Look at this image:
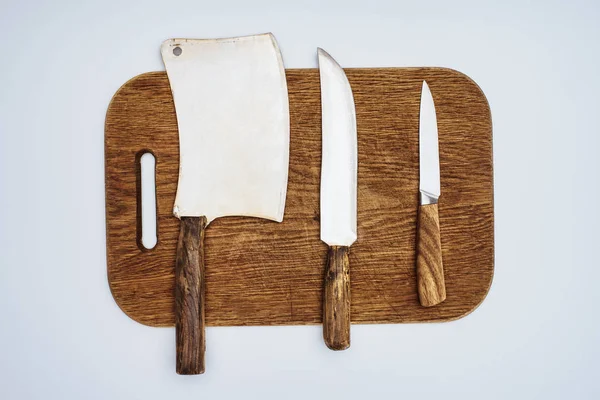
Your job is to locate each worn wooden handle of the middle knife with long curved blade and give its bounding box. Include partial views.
[323,246,350,350]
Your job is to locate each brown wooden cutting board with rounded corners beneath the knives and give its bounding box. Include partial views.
[105,68,494,326]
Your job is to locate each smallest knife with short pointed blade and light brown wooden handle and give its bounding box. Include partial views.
[417,81,446,307]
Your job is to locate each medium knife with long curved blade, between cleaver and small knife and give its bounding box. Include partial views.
[317,49,358,350]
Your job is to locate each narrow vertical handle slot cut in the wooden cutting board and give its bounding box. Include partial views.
[136,150,158,250]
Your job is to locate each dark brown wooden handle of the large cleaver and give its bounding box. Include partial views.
[175,217,206,375]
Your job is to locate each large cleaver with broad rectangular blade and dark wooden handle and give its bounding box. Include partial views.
[161,34,290,375]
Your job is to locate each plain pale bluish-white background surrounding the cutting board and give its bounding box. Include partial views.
[0,0,600,399]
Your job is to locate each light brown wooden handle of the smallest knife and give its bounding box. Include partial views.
[417,204,446,307]
